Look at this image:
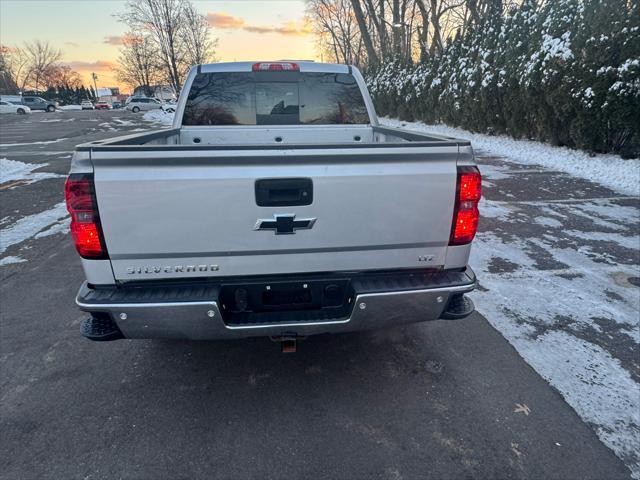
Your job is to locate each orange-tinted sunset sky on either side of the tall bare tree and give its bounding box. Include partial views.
[0,0,317,93]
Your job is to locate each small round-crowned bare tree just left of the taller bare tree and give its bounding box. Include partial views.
[114,32,161,96]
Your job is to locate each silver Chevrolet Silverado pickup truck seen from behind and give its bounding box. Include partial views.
[65,62,481,348]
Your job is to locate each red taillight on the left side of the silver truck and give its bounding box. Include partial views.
[64,173,109,260]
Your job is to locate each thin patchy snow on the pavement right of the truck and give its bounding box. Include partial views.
[470,199,640,478]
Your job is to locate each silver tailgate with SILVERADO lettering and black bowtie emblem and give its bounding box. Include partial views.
[91,146,457,281]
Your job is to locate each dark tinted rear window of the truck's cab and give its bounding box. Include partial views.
[182,72,369,126]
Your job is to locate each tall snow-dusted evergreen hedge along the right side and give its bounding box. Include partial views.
[367,0,640,157]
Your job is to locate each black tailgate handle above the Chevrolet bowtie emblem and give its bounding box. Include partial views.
[256,178,313,207]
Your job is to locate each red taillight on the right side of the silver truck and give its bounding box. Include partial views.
[449,167,482,245]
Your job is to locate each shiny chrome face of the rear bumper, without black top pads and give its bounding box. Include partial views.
[76,268,476,340]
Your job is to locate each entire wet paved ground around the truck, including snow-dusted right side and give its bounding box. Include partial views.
[0,111,640,479]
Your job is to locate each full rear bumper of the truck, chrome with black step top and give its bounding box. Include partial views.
[76,267,476,340]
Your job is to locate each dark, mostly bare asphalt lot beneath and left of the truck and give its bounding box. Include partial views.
[0,110,637,479]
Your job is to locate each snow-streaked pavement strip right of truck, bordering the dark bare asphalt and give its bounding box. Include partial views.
[470,152,640,475]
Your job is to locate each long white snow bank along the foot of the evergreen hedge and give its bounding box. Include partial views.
[380,118,640,196]
